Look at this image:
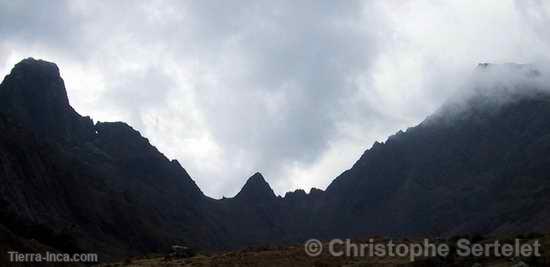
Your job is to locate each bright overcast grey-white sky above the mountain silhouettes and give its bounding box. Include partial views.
[0,0,550,197]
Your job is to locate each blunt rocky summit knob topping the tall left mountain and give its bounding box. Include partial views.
[0,58,93,140]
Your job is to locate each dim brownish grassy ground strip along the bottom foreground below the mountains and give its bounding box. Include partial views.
[97,235,550,267]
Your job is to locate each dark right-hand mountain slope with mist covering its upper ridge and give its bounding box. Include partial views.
[321,63,550,240]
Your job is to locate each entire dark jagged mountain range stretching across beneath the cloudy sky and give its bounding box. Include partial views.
[0,59,550,258]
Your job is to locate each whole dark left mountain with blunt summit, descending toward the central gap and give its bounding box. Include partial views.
[0,59,220,258]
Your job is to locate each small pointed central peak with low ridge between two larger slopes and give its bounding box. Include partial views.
[212,173,323,248]
